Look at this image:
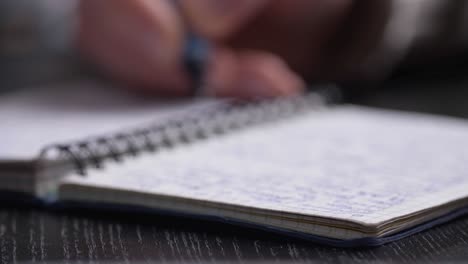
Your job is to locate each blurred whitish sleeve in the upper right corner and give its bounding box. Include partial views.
[359,0,468,79]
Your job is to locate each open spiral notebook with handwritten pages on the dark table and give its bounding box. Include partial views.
[0,82,468,247]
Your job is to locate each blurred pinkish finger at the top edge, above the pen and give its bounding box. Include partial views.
[180,0,268,40]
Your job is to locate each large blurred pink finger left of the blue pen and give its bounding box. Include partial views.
[78,0,188,94]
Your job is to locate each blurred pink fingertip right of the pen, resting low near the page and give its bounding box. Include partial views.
[207,49,305,100]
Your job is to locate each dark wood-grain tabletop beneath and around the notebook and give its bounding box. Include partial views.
[0,73,468,263]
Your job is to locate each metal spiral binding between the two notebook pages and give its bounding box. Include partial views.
[40,89,332,176]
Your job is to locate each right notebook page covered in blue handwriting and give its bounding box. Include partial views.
[64,106,468,225]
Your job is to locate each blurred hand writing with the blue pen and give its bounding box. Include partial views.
[78,0,392,99]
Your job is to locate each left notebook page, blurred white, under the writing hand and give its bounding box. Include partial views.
[0,81,228,161]
